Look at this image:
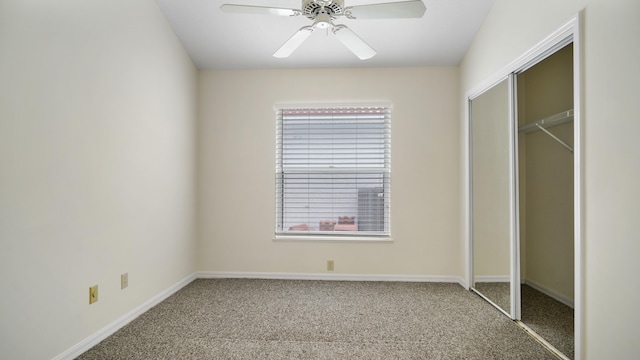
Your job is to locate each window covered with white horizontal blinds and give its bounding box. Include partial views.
[276,106,391,237]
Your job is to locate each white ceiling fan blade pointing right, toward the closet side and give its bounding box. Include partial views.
[345,0,427,19]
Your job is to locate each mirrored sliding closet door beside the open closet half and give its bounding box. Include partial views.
[469,77,517,319]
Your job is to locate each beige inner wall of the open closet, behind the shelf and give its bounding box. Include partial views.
[518,46,574,301]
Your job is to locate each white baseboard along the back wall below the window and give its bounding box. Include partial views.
[197,271,465,287]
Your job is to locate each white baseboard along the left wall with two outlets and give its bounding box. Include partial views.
[53,273,196,360]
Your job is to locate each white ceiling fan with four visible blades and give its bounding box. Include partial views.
[220,0,426,60]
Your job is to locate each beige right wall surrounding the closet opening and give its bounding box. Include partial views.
[460,0,640,359]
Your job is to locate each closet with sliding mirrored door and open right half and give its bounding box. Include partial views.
[468,32,580,359]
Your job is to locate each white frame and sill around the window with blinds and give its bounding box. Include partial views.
[274,102,392,242]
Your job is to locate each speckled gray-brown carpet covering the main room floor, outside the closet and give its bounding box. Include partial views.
[78,279,555,360]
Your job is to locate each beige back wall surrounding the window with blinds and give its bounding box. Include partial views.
[198,67,462,277]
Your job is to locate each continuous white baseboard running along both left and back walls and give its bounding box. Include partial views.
[52,271,466,360]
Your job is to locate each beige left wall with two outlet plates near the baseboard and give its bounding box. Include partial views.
[0,0,196,359]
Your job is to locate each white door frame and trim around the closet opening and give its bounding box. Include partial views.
[463,12,585,360]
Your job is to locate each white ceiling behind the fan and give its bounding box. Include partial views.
[156,0,493,70]
